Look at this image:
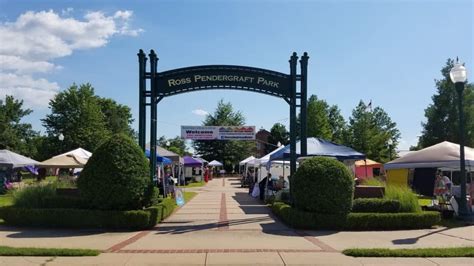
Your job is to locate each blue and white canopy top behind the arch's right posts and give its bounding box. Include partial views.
[269,138,366,162]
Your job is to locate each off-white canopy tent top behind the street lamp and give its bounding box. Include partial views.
[384,141,474,171]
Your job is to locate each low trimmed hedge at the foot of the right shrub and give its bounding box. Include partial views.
[271,202,441,230]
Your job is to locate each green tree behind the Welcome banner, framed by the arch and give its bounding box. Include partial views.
[193,100,254,170]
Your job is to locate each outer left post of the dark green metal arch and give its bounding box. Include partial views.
[137,49,147,151]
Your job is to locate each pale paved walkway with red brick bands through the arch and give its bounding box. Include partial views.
[0,178,474,265]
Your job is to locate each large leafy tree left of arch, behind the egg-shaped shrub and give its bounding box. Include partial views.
[42,83,133,156]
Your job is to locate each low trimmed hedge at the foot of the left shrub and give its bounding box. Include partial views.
[0,196,180,230]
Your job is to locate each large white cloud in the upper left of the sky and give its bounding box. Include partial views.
[0,8,143,107]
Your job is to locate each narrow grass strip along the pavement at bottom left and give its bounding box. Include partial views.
[0,246,100,257]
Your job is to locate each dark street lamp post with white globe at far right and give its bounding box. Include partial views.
[449,60,469,218]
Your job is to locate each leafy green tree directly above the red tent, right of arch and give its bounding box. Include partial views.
[347,101,400,162]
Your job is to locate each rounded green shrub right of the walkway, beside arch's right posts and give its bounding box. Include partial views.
[291,157,354,215]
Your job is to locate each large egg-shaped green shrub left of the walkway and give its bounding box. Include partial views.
[77,135,151,210]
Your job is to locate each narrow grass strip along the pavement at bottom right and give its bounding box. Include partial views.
[342,247,474,258]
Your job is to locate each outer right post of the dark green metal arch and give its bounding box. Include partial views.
[300,52,309,156]
